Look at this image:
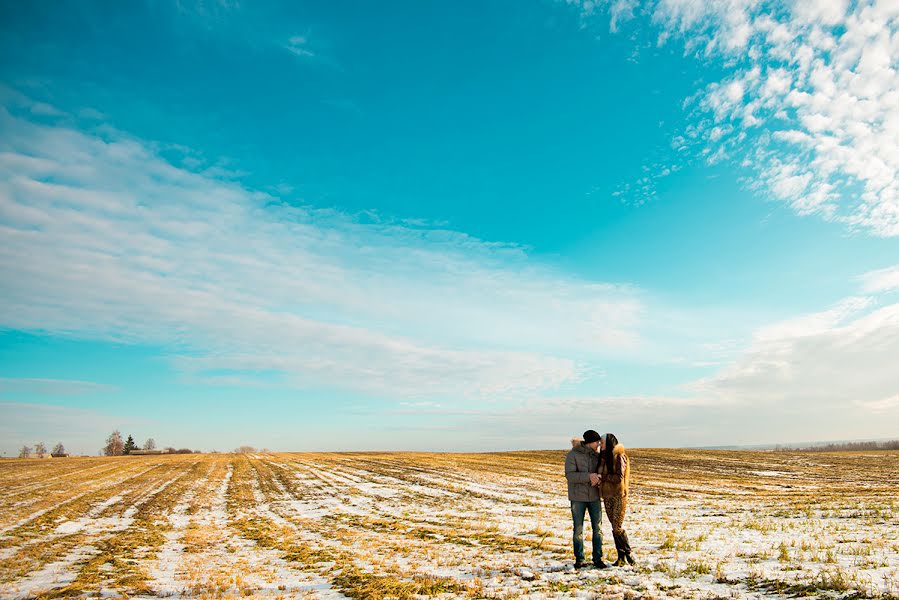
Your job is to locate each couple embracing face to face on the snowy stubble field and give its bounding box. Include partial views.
[565,429,635,569]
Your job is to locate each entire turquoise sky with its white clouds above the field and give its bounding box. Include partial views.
[0,0,899,456]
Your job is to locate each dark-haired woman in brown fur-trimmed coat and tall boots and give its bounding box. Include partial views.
[599,433,636,567]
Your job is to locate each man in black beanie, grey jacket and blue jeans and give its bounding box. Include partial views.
[565,429,606,569]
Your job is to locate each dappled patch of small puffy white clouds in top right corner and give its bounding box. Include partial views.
[568,0,899,236]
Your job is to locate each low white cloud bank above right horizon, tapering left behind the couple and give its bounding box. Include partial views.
[430,267,899,446]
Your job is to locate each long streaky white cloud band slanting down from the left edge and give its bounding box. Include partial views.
[0,102,644,404]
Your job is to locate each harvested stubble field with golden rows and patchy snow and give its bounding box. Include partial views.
[0,450,899,598]
